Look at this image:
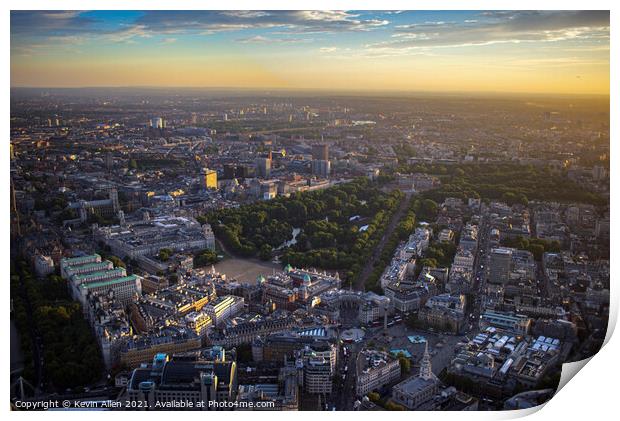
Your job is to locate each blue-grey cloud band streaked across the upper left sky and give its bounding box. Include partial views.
[11,10,389,50]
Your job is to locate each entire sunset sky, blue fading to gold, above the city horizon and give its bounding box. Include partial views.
[11,10,610,95]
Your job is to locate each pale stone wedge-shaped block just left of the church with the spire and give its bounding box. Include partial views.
[355,350,400,397]
